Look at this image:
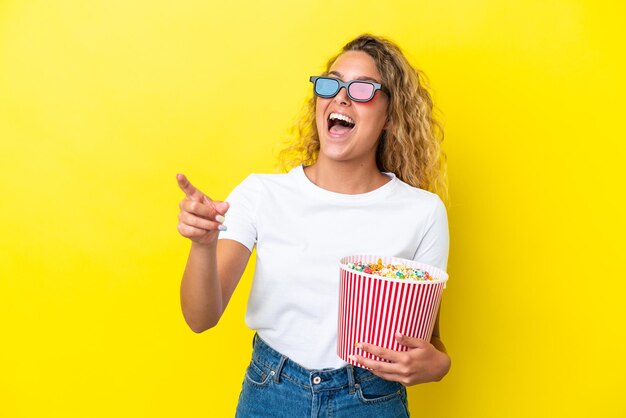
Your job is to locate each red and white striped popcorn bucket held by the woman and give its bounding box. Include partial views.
[337,255,448,367]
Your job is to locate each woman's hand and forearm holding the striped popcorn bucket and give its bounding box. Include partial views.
[353,313,450,386]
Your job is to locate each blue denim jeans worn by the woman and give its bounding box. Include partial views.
[236,335,409,418]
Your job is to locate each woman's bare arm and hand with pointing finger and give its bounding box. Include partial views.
[176,174,250,333]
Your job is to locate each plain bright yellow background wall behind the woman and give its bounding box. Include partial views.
[0,0,626,418]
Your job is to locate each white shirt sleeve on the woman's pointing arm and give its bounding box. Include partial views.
[218,175,260,252]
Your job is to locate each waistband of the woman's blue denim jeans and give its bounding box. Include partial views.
[252,334,377,393]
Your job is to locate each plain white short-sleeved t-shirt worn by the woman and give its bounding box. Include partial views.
[219,166,449,369]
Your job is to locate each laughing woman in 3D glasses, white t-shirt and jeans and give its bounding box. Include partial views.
[177,35,450,417]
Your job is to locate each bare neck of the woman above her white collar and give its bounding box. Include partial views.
[304,158,389,194]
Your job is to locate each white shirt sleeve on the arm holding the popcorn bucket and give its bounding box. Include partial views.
[413,197,450,271]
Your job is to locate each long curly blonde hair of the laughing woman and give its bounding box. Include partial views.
[279,34,448,202]
